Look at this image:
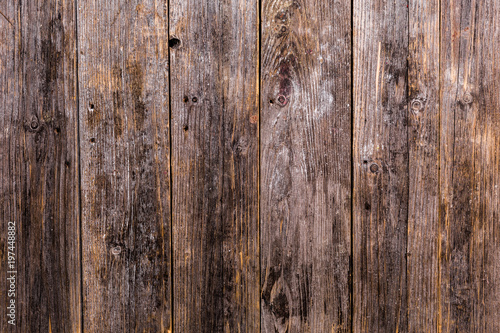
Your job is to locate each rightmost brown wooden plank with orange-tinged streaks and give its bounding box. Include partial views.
[440,0,500,332]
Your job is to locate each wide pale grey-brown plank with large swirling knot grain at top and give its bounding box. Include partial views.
[261,0,352,332]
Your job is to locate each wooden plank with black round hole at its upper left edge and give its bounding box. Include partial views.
[170,0,260,332]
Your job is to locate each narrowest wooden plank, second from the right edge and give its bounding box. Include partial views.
[407,0,440,332]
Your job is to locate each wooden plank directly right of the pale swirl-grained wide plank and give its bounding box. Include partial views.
[353,0,409,333]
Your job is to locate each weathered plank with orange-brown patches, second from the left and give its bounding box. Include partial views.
[78,0,172,332]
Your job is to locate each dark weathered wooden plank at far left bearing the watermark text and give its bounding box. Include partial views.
[0,0,81,332]
